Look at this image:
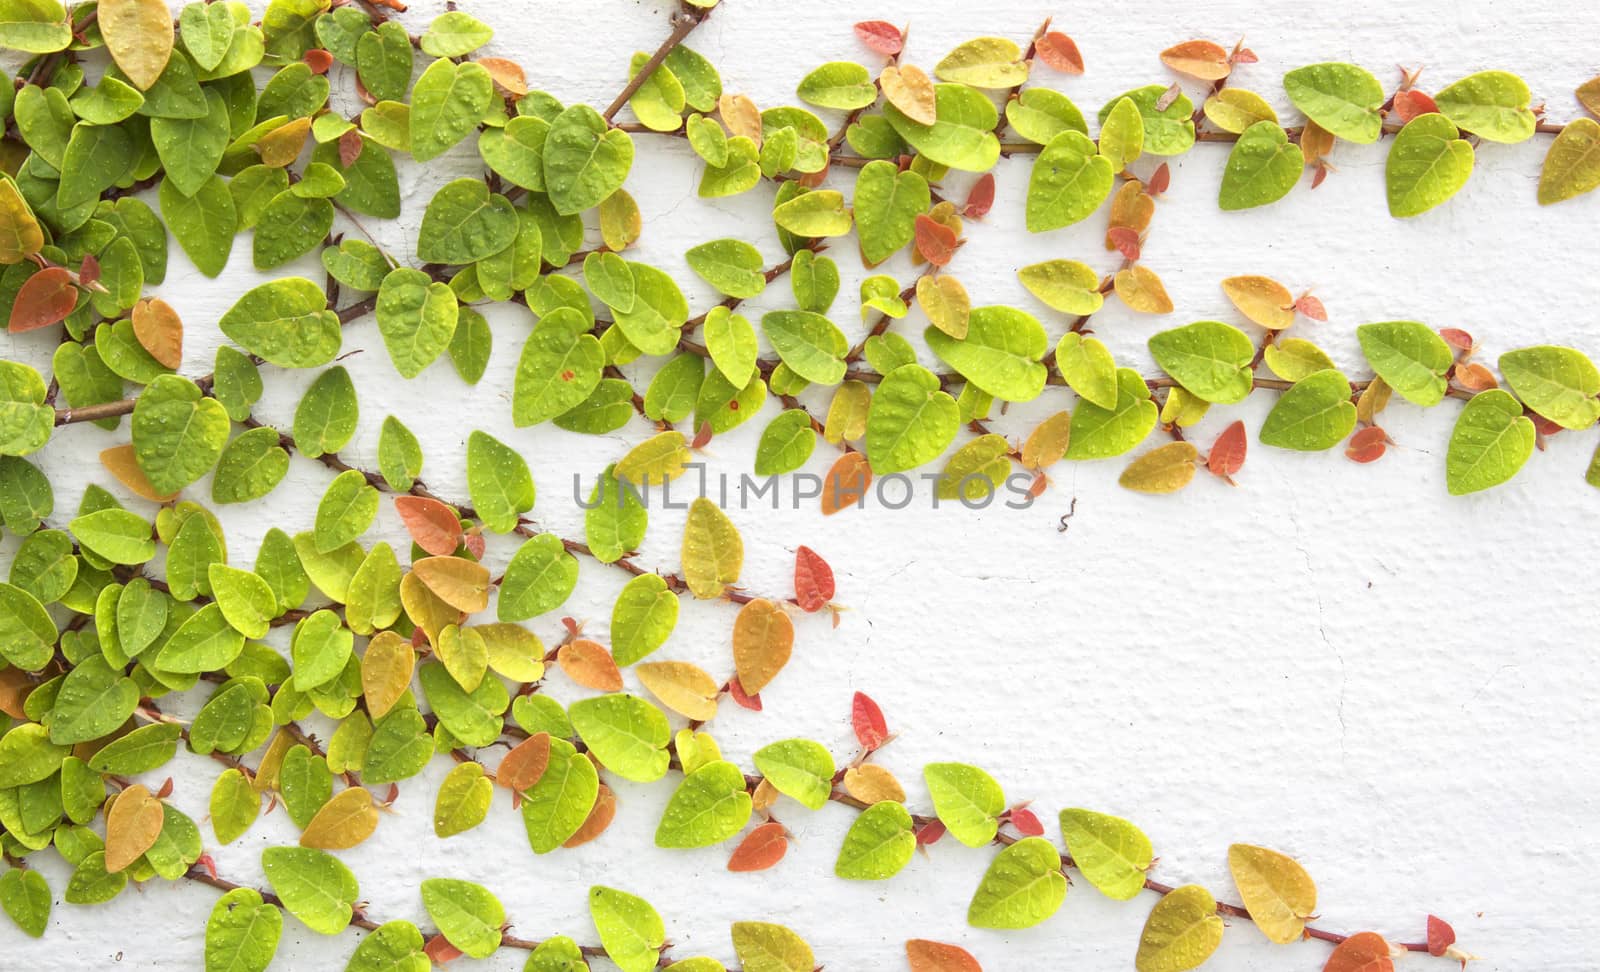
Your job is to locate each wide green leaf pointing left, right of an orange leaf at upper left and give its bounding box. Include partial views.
[218,277,342,368]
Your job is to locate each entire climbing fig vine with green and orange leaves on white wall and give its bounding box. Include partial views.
[0,0,1580,972]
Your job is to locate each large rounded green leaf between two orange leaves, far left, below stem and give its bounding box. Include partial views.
[133,374,230,492]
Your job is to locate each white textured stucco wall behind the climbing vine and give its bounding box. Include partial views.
[0,0,1600,972]
